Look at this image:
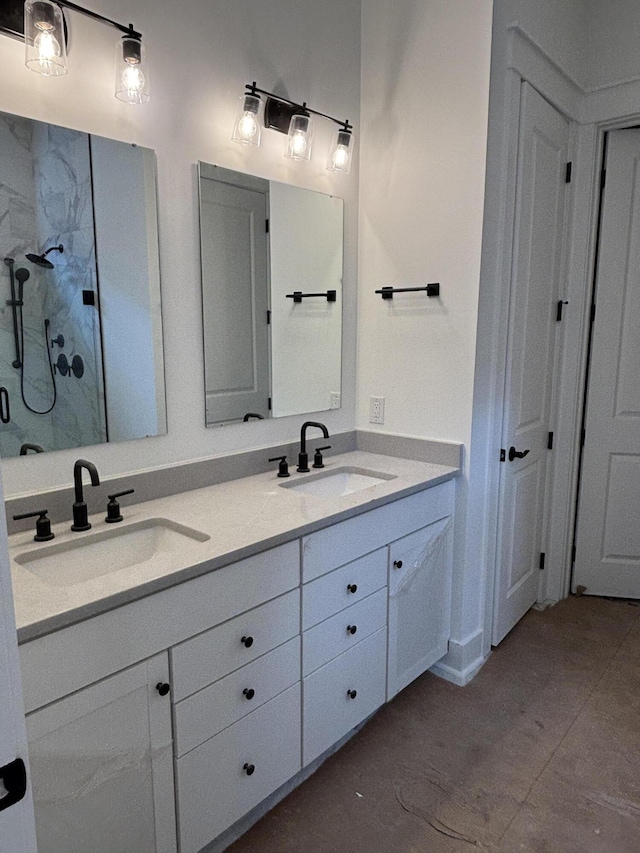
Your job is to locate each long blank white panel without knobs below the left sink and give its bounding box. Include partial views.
[19,541,300,711]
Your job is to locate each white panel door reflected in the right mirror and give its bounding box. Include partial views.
[200,164,269,424]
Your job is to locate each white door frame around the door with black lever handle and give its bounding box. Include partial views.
[466,20,628,655]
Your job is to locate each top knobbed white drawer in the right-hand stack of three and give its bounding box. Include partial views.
[302,548,387,631]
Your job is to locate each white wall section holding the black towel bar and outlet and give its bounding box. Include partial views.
[357,0,492,444]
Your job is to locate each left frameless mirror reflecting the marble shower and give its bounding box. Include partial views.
[0,113,166,457]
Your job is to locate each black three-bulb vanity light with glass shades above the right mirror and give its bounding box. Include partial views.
[231,81,353,175]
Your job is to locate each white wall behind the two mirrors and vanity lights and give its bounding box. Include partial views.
[0,0,360,496]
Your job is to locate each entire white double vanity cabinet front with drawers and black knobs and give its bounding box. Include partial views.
[20,481,454,853]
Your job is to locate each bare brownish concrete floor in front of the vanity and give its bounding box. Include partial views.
[228,596,640,853]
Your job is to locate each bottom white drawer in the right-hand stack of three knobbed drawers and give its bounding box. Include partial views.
[302,628,387,765]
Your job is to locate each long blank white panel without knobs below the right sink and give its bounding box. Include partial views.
[302,480,454,583]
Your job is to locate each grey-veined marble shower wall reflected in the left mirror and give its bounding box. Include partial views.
[0,114,106,456]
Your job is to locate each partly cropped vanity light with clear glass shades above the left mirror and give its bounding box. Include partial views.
[16,0,151,104]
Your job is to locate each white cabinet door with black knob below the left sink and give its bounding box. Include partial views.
[26,654,176,853]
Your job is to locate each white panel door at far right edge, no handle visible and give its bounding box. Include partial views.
[573,130,640,598]
